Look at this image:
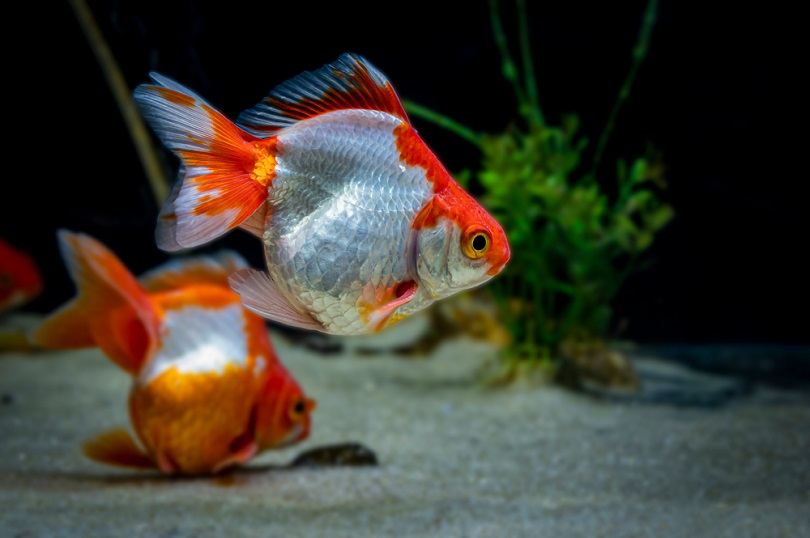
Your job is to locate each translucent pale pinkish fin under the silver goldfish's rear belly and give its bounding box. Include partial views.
[228,269,324,331]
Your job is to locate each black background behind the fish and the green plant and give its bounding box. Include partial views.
[0,0,810,343]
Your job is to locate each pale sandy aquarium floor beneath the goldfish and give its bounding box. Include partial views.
[0,320,810,538]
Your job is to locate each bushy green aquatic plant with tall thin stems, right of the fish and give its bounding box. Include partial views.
[406,0,673,384]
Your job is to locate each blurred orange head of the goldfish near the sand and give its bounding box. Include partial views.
[256,362,316,450]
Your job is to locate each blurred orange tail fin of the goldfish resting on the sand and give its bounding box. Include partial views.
[31,230,159,373]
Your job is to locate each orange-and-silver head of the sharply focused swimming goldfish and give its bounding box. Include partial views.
[417,187,511,298]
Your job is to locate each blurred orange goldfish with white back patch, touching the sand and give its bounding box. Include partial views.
[31,231,315,474]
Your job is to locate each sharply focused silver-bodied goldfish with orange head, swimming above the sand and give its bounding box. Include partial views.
[134,54,510,335]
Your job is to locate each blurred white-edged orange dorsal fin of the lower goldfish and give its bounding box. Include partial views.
[140,250,248,293]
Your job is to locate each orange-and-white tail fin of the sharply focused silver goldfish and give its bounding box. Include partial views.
[134,73,276,251]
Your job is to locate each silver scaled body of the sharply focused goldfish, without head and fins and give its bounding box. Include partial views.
[262,110,434,334]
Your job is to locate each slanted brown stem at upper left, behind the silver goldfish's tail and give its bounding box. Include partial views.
[69,0,169,206]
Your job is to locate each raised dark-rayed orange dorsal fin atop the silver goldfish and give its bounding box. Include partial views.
[236,53,408,137]
